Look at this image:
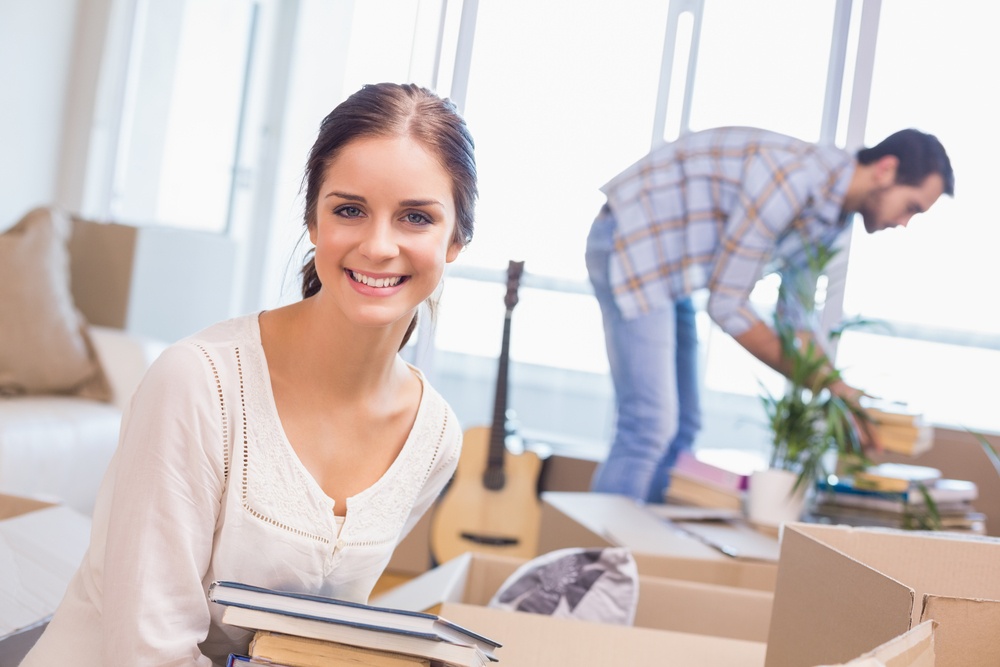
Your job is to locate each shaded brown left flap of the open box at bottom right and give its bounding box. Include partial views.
[766,524,914,667]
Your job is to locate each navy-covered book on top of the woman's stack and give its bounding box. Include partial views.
[208,581,501,661]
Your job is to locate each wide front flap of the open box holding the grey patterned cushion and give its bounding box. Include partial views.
[441,602,764,667]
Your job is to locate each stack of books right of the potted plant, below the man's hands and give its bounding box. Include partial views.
[809,464,986,535]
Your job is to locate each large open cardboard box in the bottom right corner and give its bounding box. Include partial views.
[766,523,1000,667]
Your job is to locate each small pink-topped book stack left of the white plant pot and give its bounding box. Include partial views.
[665,449,767,510]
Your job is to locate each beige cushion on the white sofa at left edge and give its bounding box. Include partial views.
[0,208,111,401]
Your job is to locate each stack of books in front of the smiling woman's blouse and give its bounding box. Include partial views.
[214,581,500,667]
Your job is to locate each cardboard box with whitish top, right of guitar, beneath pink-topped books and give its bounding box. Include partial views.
[539,492,779,591]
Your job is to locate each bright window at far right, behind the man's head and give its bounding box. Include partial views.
[838,0,1000,431]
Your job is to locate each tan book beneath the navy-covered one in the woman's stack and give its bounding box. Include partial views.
[249,630,430,667]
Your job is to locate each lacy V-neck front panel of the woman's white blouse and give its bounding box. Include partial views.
[209,316,459,560]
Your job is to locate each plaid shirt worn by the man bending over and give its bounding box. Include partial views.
[601,127,855,336]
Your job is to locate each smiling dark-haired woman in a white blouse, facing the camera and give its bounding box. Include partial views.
[22,84,477,667]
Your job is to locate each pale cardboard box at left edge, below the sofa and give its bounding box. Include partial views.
[0,494,90,665]
